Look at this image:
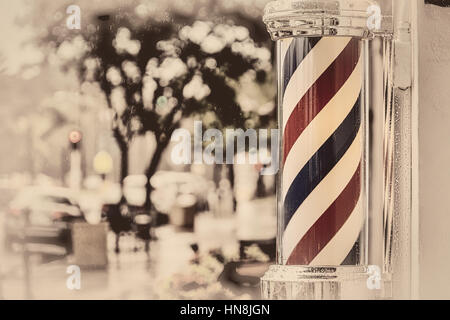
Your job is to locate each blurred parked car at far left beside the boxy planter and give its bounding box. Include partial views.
[5,187,84,253]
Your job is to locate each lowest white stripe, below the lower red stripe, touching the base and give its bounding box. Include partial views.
[310,195,364,266]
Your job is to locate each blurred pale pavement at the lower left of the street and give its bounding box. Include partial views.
[2,226,193,299]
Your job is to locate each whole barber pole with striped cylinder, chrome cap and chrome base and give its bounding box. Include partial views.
[261,0,398,300]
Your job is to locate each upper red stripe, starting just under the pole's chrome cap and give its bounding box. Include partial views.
[283,39,359,164]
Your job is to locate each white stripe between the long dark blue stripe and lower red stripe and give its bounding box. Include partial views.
[282,129,362,263]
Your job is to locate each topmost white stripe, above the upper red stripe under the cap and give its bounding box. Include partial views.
[283,37,351,130]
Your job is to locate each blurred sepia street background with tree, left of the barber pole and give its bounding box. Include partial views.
[0,0,278,299]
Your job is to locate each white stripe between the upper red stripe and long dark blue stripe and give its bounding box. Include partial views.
[282,57,362,199]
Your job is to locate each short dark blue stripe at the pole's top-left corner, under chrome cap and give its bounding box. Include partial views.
[281,37,321,97]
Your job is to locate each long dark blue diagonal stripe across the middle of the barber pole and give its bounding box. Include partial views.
[284,97,361,228]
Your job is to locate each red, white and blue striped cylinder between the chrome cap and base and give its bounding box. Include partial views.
[278,37,364,266]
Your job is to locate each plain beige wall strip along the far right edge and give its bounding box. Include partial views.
[415,0,450,299]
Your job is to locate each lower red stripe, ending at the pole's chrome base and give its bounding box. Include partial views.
[287,166,361,265]
